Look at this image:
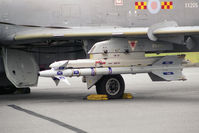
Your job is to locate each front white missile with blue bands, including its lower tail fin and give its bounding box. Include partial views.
[39,66,182,80]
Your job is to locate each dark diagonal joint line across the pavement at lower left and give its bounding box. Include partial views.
[8,104,87,133]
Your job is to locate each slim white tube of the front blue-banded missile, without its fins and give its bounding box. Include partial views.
[39,66,179,77]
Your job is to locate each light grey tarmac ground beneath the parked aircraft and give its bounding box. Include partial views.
[0,68,199,133]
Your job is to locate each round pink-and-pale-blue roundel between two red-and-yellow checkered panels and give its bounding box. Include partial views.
[147,0,161,14]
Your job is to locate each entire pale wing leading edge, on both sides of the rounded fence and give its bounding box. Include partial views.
[10,26,199,41]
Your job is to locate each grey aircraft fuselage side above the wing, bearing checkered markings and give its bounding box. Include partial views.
[0,0,199,30]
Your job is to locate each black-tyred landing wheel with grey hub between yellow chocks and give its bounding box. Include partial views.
[96,75,125,99]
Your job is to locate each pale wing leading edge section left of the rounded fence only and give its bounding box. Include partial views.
[13,27,147,40]
